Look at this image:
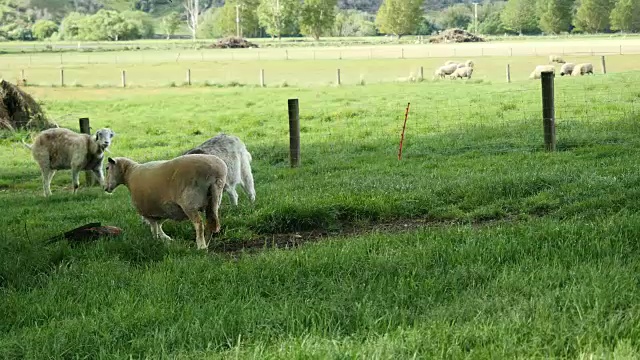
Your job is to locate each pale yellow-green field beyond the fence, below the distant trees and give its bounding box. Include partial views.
[0,37,640,87]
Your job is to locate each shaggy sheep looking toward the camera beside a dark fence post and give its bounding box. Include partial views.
[22,128,116,197]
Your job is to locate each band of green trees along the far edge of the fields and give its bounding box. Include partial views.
[0,0,640,41]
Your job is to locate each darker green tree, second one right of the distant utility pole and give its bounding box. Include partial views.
[300,0,338,40]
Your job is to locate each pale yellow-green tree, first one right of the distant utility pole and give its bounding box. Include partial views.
[258,0,300,39]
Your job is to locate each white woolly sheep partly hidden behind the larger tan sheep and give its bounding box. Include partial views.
[183,133,256,205]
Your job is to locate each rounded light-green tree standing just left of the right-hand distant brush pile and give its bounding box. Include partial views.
[376,0,424,39]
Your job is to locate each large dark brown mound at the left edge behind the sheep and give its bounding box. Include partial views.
[0,79,56,131]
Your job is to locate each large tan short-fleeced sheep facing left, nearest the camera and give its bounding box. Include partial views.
[104,154,227,250]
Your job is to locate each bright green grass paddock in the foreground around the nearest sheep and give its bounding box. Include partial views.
[0,65,640,359]
